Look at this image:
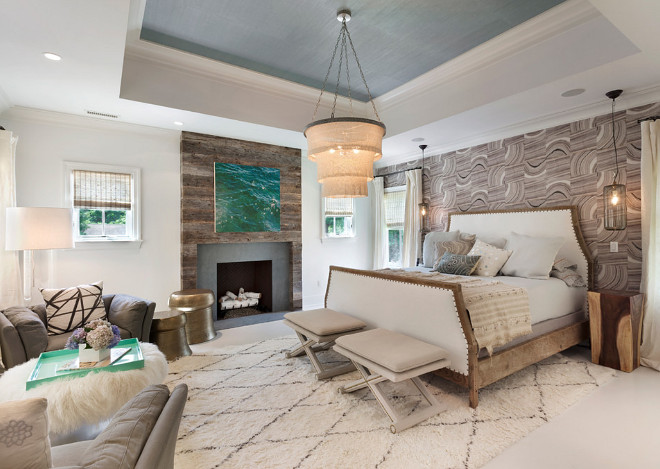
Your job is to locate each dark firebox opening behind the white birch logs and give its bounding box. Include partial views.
[217,260,273,318]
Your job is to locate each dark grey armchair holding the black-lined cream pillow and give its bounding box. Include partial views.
[0,294,156,369]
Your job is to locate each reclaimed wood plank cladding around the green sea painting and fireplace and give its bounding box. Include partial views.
[181,132,302,309]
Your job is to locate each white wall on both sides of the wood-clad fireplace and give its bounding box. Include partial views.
[0,109,372,309]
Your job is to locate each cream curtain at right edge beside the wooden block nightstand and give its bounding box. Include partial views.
[641,121,660,370]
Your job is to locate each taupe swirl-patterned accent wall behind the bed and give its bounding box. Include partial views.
[376,103,660,290]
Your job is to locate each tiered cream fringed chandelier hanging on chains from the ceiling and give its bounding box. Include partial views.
[304,10,385,198]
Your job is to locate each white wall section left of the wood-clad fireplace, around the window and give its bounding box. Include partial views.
[0,110,180,309]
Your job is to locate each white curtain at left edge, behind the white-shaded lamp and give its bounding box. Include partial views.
[0,130,23,310]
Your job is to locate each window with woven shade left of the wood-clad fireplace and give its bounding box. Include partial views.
[65,163,140,242]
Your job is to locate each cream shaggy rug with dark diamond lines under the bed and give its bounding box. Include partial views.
[166,336,615,469]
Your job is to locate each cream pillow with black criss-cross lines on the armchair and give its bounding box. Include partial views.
[41,282,106,335]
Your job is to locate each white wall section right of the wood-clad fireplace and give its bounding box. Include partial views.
[302,150,373,309]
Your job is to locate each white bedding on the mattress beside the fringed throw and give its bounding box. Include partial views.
[406,267,587,326]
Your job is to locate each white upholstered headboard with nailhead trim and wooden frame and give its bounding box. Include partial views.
[447,205,594,288]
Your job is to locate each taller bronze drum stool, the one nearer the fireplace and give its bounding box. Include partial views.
[167,290,216,344]
